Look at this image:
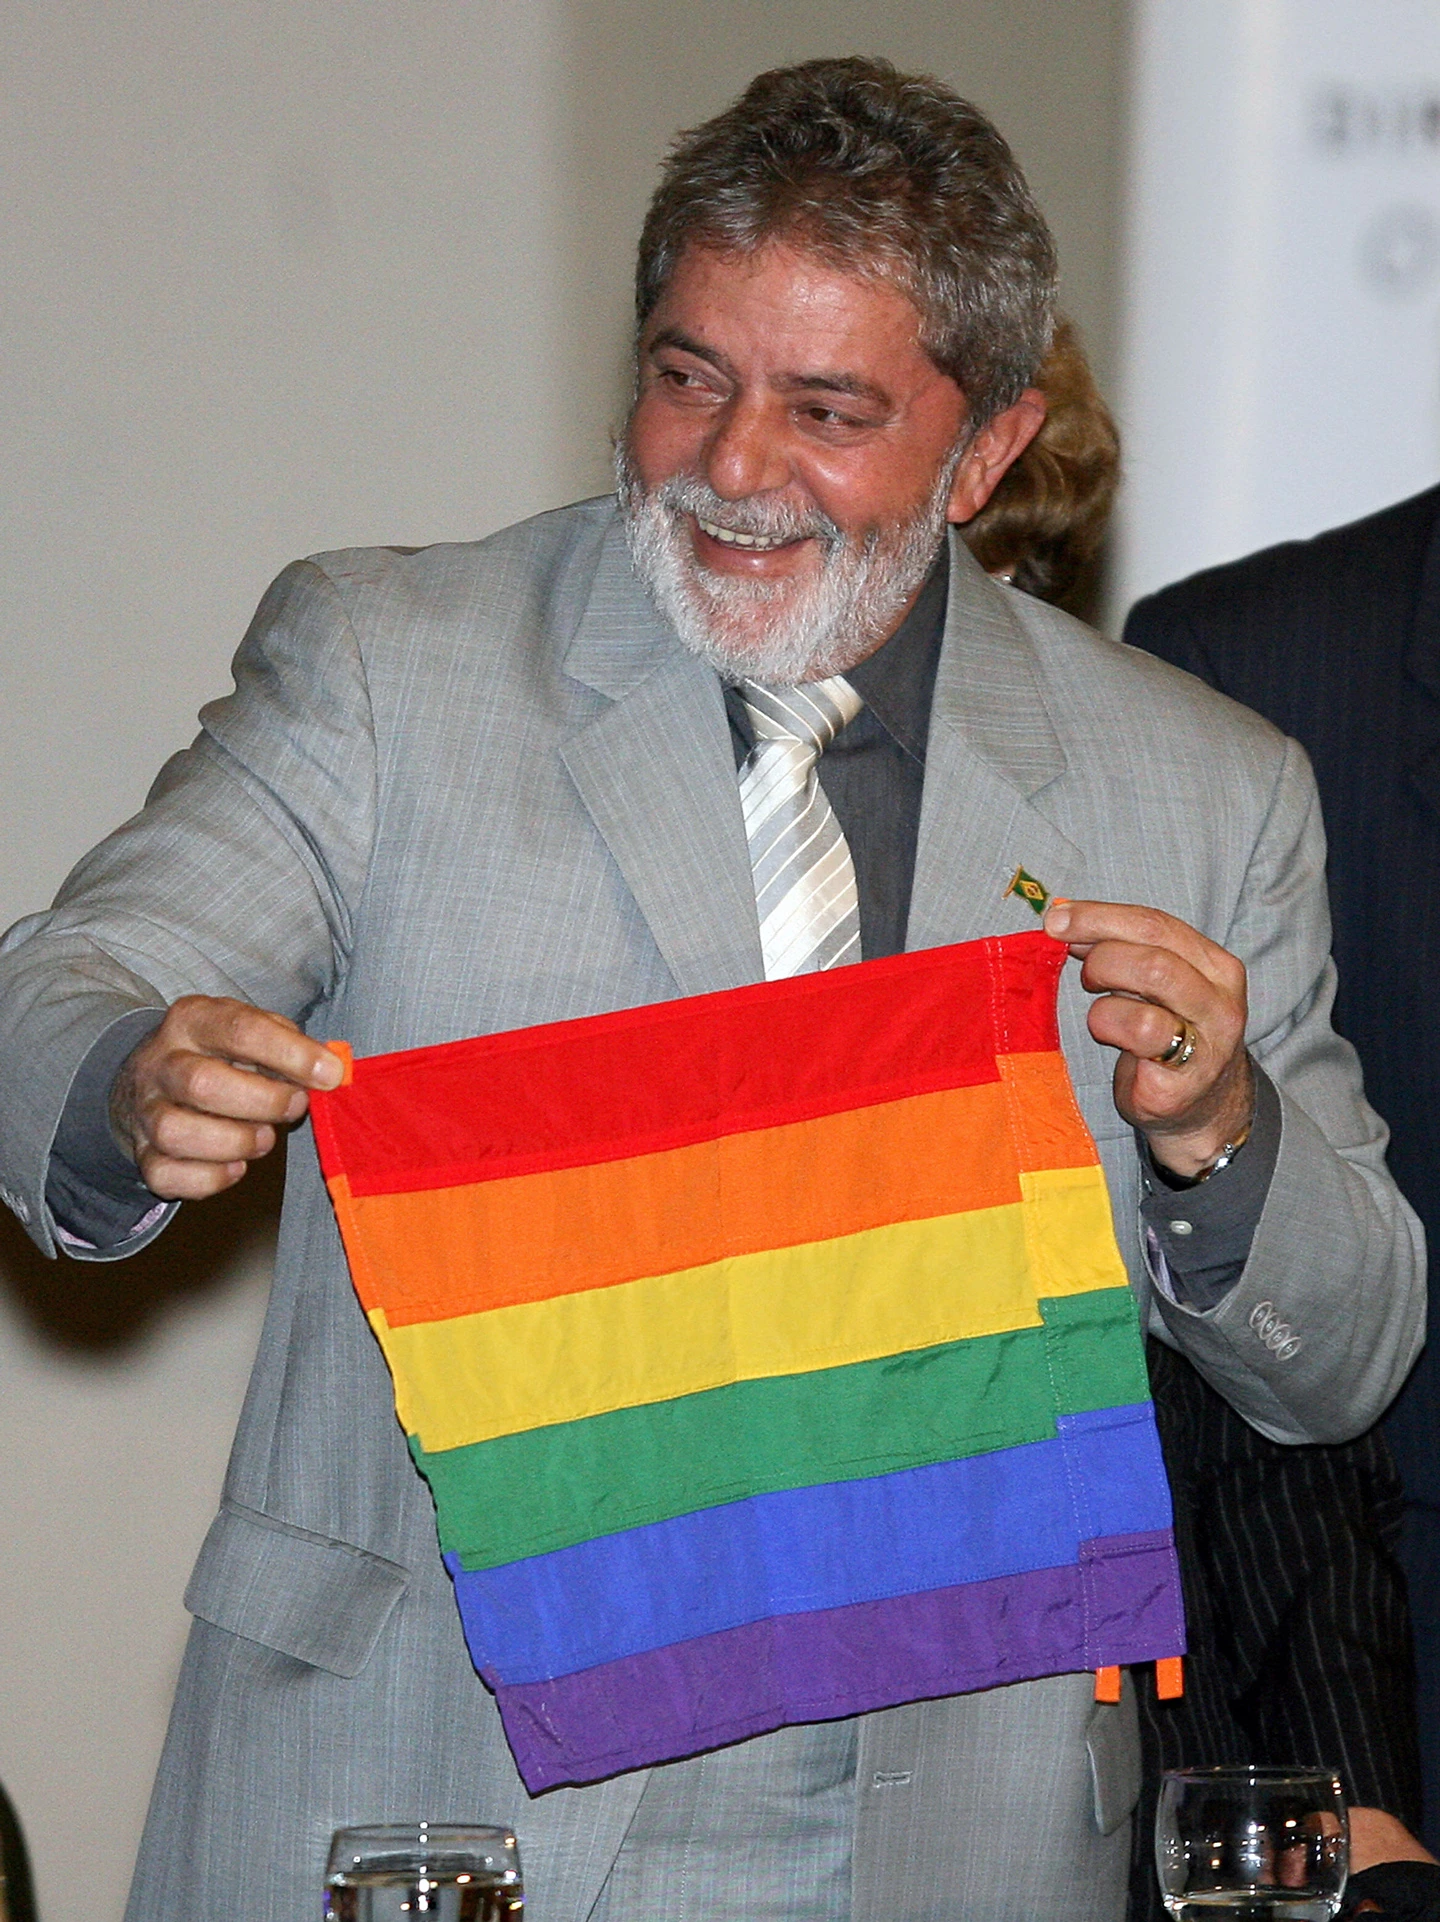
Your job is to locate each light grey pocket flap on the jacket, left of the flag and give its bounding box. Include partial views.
[185,1503,408,1676]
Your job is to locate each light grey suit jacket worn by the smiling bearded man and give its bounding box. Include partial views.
[0,502,1423,1922]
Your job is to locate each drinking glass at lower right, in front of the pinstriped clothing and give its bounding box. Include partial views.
[1155,1766,1350,1922]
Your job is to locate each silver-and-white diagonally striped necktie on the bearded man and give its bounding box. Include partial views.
[740,675,865,980]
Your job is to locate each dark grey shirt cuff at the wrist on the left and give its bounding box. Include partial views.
[44,1007,167,1249]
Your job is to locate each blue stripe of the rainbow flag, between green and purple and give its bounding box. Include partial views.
[446,1401,1171,1686]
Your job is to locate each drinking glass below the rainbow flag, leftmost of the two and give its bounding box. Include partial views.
[325,1822,525,1922]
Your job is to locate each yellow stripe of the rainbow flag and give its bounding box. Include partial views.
[371,1169,1125,1453]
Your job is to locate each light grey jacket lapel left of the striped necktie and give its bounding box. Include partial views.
[561,521,763,994]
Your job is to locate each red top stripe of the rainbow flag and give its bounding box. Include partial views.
[311,932,1065,1195]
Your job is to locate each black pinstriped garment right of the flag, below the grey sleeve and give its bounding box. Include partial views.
[1130,1342,1421,1922]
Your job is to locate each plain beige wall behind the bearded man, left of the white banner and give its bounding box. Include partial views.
[0,0,1125,1922]
